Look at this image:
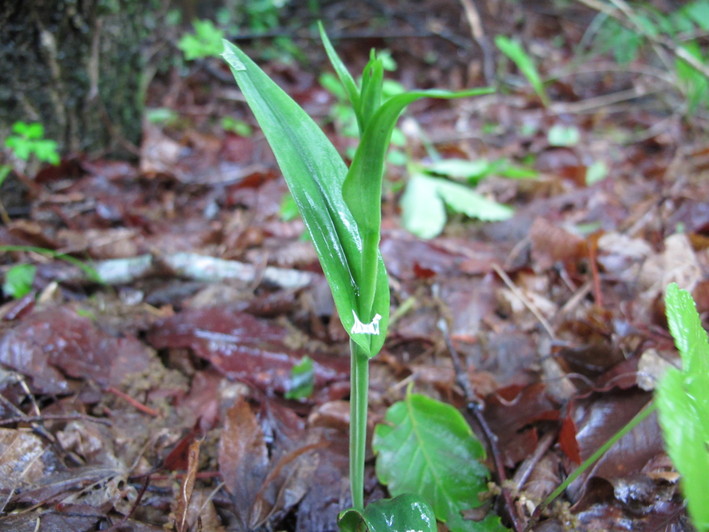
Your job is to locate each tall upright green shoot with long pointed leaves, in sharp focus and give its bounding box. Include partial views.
[223,22,490,531]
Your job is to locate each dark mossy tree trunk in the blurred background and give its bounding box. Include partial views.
[0,0,146,156]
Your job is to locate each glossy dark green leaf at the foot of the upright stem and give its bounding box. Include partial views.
[338,494,438,532]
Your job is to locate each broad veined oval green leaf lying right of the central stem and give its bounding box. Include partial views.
[372,393,499,532]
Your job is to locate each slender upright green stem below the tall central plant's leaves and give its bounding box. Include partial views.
[350,339,369,510]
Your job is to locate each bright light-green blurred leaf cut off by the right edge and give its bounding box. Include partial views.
[656,283,709,530]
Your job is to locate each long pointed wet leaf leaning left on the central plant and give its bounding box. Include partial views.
[223,41,389,357]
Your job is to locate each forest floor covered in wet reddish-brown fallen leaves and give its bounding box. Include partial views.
[0,0,709,531]
